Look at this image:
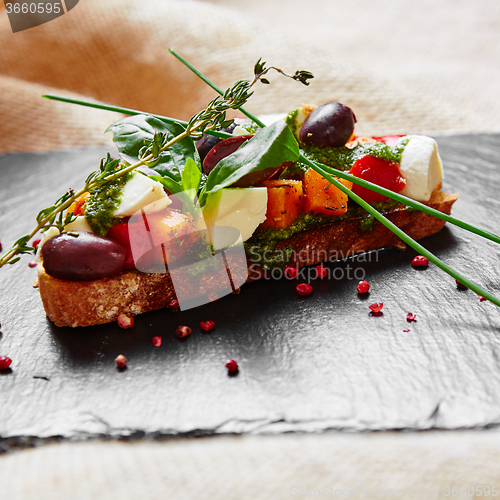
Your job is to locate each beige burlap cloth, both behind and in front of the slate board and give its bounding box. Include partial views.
[0,0,500,500]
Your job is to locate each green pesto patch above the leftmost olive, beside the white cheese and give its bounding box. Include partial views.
[85,174,133,236]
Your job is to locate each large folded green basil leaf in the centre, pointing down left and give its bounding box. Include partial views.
[200,120,299,205]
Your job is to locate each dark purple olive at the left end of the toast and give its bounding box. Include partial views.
[42,232,127,281]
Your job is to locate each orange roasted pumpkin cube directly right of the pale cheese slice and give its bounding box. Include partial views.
[262,179,304,229]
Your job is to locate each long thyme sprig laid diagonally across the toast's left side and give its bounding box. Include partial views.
[0,54,313,268]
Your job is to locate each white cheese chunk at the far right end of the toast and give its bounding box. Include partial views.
[399,135,444,202]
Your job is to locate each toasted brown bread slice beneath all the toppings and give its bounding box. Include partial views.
[38,191,458,327]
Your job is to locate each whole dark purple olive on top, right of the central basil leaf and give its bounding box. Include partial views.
[299,102,356,148]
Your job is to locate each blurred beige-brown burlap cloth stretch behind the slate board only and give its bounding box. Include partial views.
[0,0,500,153]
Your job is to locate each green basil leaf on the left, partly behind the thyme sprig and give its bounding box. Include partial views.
[106,115,201,182]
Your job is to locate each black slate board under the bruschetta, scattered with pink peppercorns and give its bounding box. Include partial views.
[0,134,500,441]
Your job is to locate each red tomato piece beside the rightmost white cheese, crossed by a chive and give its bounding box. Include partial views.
[349,155,406,203]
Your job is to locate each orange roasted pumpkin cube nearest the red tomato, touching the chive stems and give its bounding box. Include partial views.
[304,168,352,216]
